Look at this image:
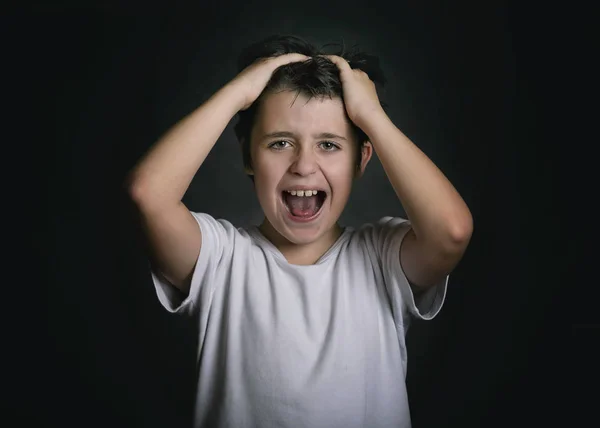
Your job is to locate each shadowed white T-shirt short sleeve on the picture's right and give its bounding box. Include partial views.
[376,217,449,326]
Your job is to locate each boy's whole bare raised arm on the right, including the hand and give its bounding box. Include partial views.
[328,56,473,290]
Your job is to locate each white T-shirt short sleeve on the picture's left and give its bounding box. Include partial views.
[150,212,237,315]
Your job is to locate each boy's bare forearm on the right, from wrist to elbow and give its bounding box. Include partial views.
[362,111,472,250]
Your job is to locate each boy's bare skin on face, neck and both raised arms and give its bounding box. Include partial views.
[127,54,473,293]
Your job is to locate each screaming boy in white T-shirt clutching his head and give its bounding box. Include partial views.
[129,36,472,428]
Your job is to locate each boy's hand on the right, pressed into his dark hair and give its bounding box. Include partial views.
[323,55,383,129]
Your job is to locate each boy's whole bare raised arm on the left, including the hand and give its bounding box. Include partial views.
[127,54,306,293]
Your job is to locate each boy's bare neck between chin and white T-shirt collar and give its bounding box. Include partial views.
[259,218,343,265]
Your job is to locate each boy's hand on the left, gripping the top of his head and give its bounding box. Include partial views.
[231,53,310,110]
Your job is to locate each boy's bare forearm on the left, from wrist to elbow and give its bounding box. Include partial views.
[127,84,242,209]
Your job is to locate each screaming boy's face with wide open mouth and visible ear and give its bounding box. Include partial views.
[248,91,372,244]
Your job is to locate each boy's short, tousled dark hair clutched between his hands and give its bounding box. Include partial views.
[234,34,386,176]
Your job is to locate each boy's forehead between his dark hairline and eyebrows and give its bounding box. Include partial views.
[254,91,351,137]
